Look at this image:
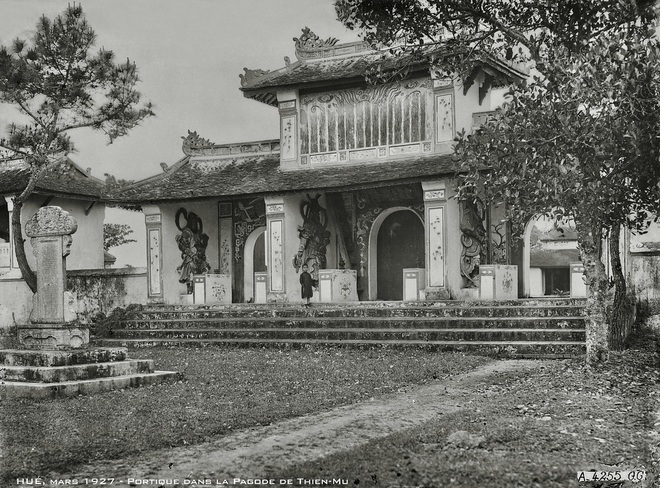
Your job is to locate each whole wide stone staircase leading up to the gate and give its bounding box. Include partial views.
[96,299,585,357]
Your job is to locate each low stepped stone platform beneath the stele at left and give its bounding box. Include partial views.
[0,347,176,399]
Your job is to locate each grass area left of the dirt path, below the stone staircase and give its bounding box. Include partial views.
[0,348,490,482]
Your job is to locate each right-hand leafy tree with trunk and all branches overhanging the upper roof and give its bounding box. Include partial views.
[335,0,660,362]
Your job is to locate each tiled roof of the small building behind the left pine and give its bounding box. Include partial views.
[0,158,105,200]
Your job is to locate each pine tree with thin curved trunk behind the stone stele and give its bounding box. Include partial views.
[0,4,153,292]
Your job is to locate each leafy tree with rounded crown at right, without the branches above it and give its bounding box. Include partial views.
[456,29,660,360]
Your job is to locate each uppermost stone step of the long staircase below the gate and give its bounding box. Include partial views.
[126,302,584,322]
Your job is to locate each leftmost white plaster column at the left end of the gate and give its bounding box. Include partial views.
[142,205,164,303]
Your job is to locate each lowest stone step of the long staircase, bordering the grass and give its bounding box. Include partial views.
[100,339,586,358]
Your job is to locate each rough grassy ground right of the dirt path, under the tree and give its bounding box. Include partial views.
[267,332,660,488]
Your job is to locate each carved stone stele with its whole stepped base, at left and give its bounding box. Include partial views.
[0,207,176,398]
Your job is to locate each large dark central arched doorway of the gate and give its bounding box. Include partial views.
[370,209,425,300]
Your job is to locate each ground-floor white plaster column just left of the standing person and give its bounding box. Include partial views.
[266,195,286,302]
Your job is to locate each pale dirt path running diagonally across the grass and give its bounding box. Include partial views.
[52,360,544,486]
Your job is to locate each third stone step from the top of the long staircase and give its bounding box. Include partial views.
[113,328,585,342]
